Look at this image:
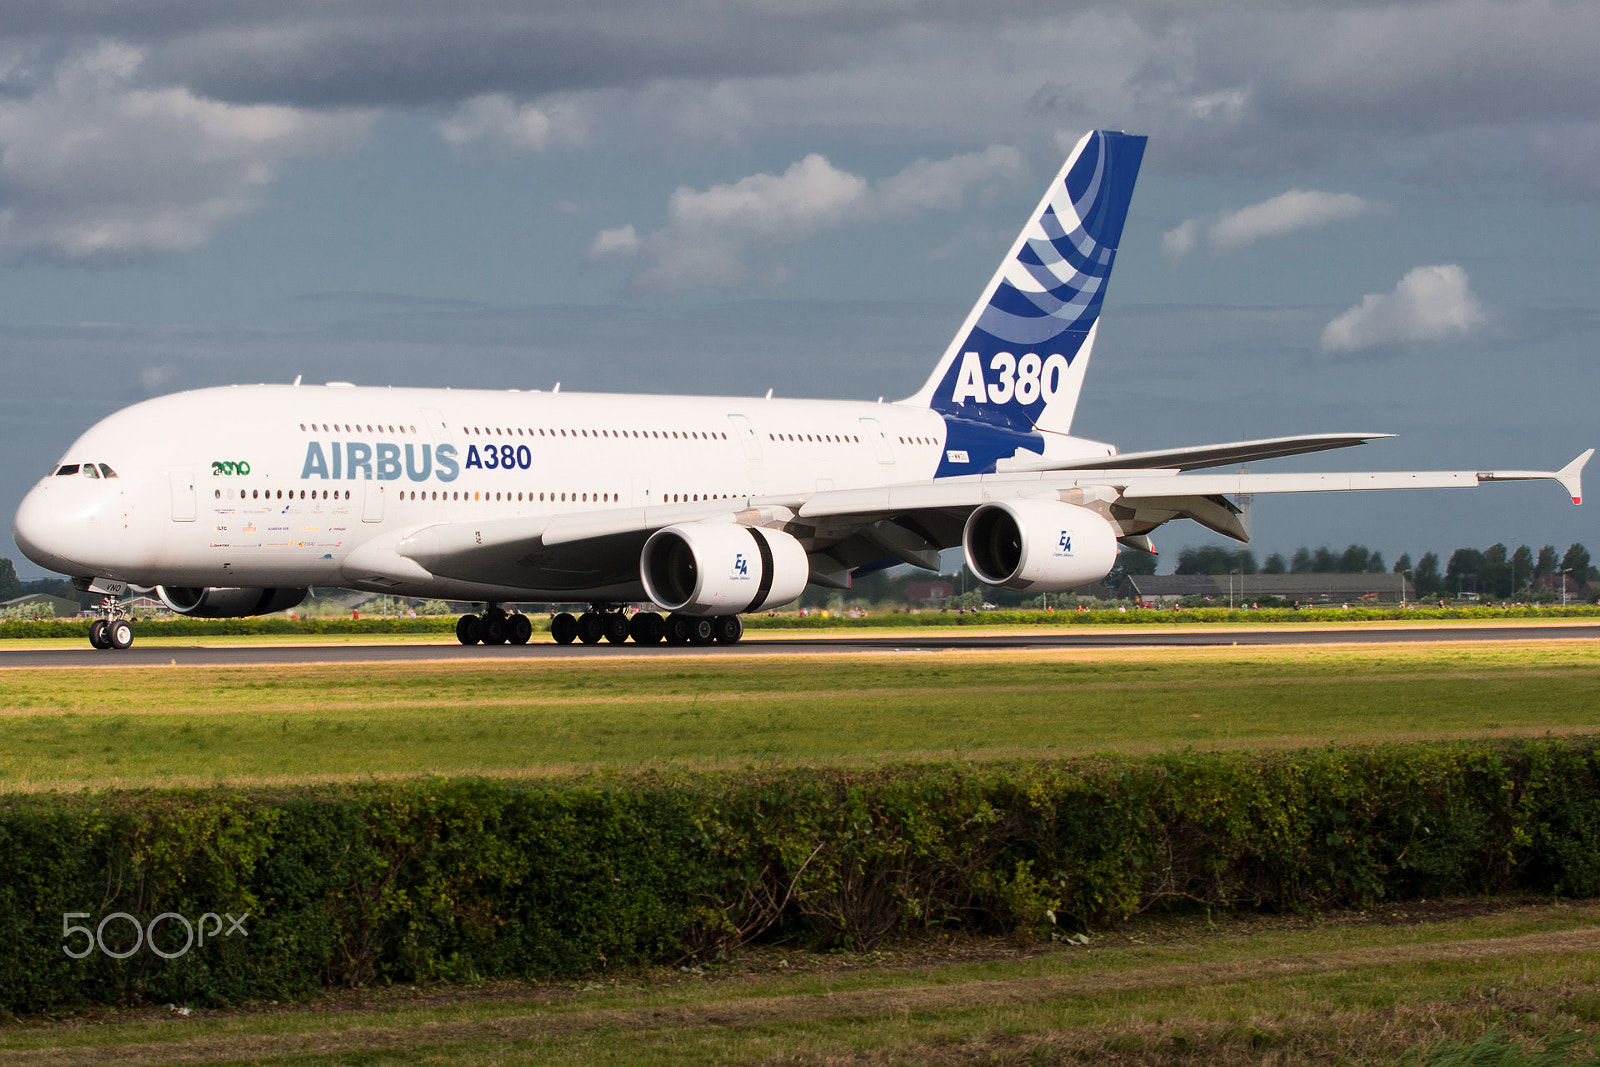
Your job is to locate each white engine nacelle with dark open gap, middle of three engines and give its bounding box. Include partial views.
[638,523,811,614]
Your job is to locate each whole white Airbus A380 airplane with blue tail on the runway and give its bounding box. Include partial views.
[14,130,1594,648]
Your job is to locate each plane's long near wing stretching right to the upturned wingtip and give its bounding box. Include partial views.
[342,451,1594,600]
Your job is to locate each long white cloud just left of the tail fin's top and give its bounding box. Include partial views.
[604,146,1021,291]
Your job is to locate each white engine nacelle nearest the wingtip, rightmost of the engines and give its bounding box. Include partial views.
[962,501,1117,592]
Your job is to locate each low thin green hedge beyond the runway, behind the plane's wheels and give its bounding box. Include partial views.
[0,605,1600,640]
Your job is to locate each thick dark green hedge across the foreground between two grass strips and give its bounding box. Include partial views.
[0,739,1600,1011]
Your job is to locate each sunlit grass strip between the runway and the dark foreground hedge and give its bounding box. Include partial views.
[0,640,1600,790]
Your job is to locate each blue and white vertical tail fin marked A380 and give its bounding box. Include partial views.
[907,130,1146,475]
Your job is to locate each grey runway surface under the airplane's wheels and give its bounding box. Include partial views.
[0,624,1600,669]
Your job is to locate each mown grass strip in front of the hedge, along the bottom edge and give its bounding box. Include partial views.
[0,902,1600,1067]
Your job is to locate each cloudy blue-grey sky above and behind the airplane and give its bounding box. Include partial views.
[0,0,1600,576]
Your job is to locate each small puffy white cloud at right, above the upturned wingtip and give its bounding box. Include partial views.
[1322,264,1488,352]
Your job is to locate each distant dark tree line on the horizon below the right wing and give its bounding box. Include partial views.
[1171,542,1600,600]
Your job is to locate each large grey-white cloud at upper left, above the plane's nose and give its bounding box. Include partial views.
[0,43,371,261]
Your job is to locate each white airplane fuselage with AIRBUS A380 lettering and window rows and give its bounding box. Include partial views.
[16,386,1112,600]
